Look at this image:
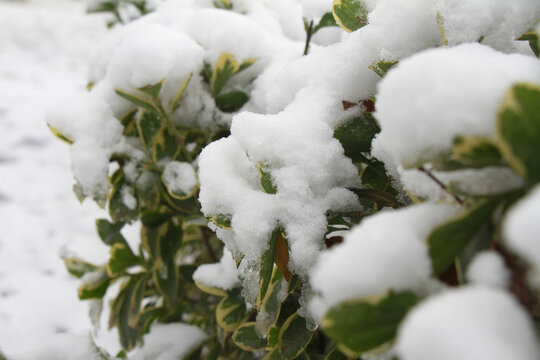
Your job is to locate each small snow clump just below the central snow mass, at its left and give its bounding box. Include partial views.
[193,249,240,290]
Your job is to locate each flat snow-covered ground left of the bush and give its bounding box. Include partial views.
[0,0,118,355]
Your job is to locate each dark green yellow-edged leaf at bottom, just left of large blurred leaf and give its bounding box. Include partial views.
[279,313,313,360]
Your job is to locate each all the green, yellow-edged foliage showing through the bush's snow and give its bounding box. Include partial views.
[51,0,540,360]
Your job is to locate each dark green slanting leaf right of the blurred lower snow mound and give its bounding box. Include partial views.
[427,196,502,275]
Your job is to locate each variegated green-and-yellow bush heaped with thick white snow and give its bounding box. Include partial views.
[47,0,540,360]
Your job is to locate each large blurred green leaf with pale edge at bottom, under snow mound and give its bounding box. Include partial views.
[321,292,419,356]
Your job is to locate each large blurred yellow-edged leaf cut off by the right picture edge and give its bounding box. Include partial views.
[497,84,540,184]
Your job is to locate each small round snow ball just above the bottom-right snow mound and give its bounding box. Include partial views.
[467,250,510,289]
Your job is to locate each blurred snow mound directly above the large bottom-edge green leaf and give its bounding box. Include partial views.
[310,203,457,315]
